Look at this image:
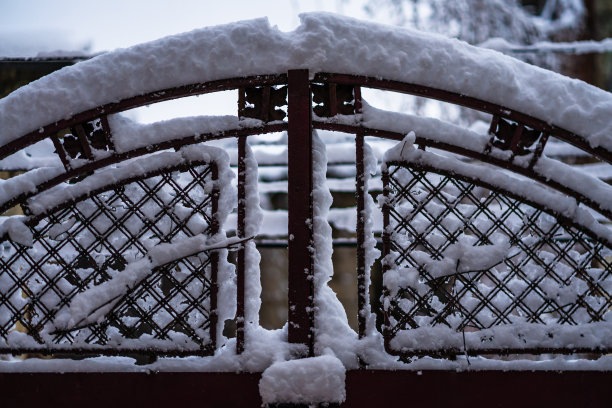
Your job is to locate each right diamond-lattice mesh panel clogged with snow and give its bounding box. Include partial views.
[383,163,612,355]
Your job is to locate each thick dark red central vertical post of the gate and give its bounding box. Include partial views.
[288,70,314,355]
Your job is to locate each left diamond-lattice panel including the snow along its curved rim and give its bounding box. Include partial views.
[0,146,236,354]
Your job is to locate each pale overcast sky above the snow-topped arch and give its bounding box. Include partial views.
[0,0,365,56]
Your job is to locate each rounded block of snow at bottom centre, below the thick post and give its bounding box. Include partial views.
[259,355,346,404]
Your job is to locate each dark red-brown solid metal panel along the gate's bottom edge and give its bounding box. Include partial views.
[0,370,612,408]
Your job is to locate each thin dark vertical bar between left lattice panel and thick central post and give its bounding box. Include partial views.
[236,137,246,354]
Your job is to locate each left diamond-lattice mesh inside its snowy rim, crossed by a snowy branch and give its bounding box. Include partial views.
[0,162,225,354]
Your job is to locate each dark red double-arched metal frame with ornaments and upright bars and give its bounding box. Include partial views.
[0,70,612,354]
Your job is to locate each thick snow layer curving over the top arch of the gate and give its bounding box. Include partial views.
[0,13,612,150]
